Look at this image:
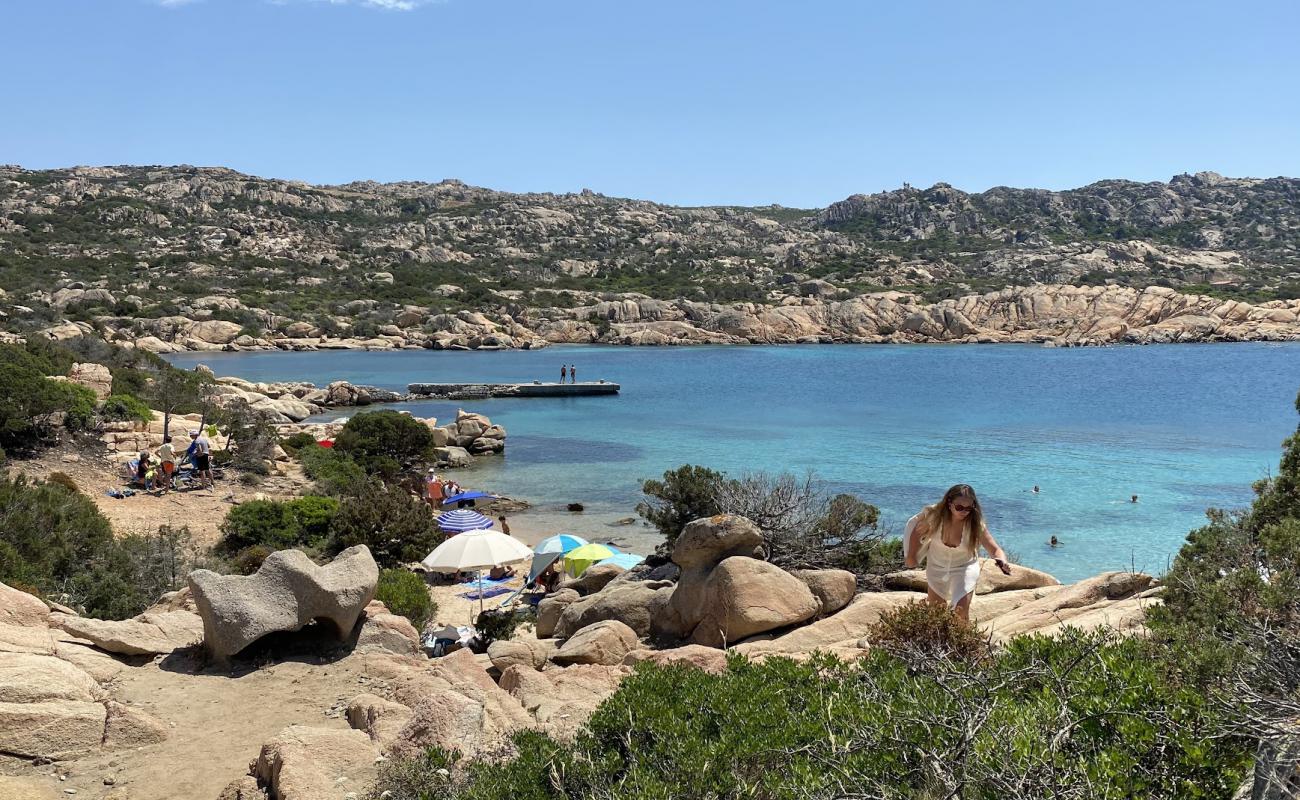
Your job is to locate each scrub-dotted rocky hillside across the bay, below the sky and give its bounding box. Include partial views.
[0,167,1300,349]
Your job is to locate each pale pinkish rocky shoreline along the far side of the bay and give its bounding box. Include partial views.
[40,285,1300,353]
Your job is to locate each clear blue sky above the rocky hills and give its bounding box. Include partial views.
[0,0,1300,207]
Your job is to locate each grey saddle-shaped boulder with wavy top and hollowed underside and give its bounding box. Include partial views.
[190,545,380,661]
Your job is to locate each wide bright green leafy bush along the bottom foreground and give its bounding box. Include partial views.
[376,632,1252,800]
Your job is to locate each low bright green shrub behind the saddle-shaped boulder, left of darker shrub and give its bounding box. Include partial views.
[220,496,339,553]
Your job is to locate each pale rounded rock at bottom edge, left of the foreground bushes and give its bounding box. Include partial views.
[248,725,380,800]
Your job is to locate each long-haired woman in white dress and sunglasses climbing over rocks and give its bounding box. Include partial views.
[904,484,1011,622]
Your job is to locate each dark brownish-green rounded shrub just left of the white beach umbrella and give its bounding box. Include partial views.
[329,481,443,567]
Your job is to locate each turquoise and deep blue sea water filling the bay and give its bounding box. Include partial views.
[172,343,1300,580]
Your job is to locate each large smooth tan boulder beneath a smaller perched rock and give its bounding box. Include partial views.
[692,555,820,647]
